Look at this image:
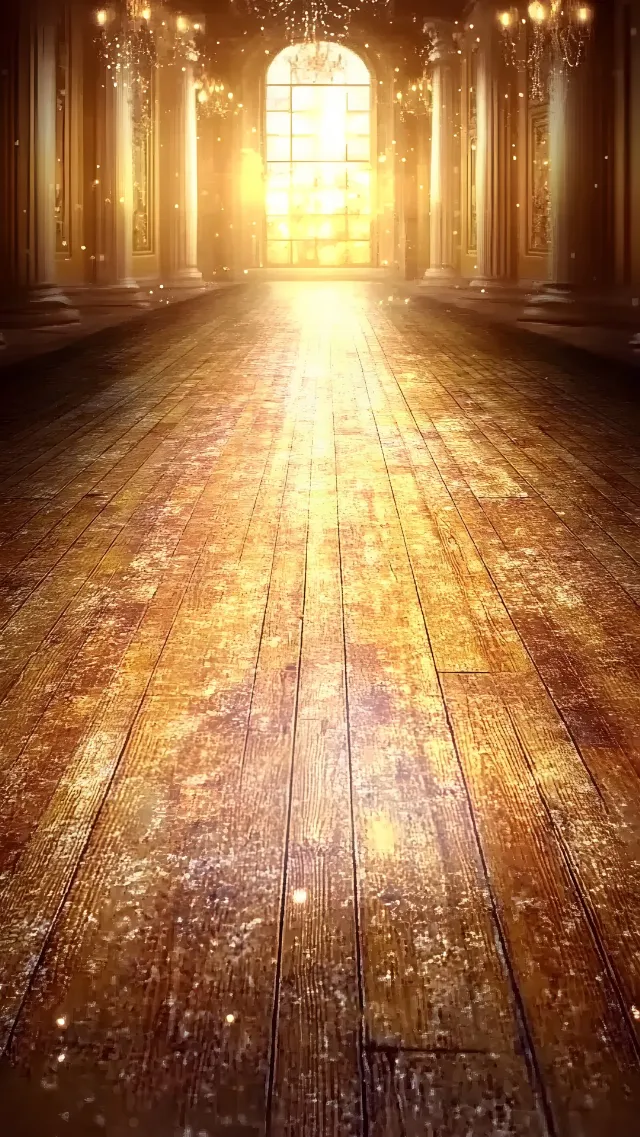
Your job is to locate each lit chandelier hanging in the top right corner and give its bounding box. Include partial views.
[498,0,593,100]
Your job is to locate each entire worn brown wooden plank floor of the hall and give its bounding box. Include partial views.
[0,282,640,1137]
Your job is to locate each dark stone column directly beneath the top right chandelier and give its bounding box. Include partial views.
[523,59,595,324]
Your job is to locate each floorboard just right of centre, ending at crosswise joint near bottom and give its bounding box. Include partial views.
[334,327,536,1052]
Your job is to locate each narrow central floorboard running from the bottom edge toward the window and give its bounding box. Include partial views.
[269,359,363,1137]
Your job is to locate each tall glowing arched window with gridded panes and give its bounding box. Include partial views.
[265,43,373,267]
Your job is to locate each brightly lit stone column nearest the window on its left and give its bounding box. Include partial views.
[160,55,202,288]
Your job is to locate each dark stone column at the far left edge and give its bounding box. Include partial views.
[0,0,80,327]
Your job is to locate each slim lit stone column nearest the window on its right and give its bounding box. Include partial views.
[424,20,457,284]
